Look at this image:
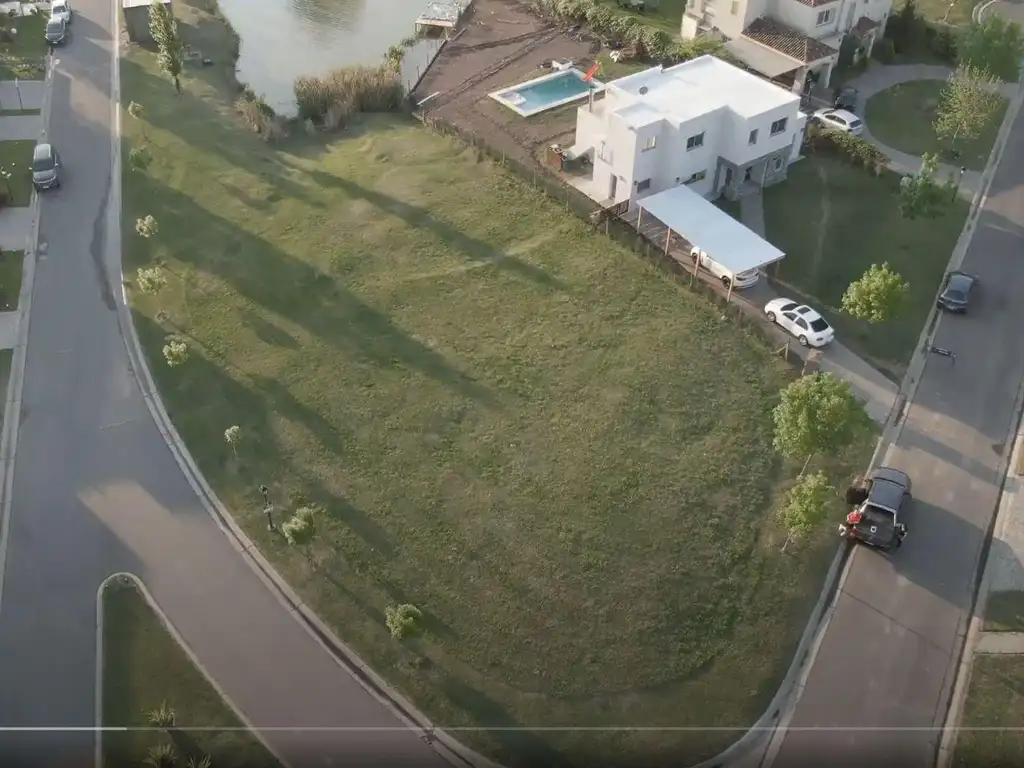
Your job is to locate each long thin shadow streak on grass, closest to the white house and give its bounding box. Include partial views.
[306,171,567,291]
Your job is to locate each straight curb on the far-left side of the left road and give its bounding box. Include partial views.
[0,49,54,618]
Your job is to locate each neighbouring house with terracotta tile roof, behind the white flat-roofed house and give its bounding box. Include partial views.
[681,0,892,93]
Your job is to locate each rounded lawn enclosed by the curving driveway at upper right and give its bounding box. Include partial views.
[864,80,1007,171]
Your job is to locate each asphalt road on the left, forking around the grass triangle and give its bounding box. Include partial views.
[0,0,452,768]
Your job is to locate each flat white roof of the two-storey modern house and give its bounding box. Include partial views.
[605,55,800,121]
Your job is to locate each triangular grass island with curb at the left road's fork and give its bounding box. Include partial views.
[102,582,280,768]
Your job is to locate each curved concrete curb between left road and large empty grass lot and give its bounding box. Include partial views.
[108,9,502,768]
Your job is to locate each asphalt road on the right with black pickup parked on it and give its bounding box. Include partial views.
[772,73,1024,768]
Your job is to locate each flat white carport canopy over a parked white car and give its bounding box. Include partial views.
[637,184,785,274]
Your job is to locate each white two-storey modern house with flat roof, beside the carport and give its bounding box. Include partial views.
[565,56,807,206]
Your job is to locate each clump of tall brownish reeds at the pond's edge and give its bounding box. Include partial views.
[295,65,406,124]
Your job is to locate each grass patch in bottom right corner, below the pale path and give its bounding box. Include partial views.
[952,654,1024,768]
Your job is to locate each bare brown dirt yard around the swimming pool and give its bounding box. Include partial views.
[413,0,601,174]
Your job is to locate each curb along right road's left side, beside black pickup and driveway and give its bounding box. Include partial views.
[693,66,1024,768]
